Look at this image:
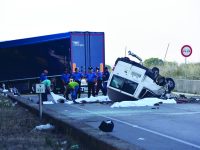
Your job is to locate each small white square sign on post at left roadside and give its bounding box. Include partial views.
[36,84,45,121]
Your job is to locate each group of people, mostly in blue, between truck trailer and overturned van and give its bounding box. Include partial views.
[40,67,110,103]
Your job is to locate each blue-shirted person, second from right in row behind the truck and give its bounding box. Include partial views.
[96,67,105,95]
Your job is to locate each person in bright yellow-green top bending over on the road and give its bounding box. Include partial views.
[68,81,79,103]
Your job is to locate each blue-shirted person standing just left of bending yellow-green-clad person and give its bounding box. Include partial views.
[61,69,71,99]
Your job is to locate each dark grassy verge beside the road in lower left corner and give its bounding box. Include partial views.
[0,95,83,150]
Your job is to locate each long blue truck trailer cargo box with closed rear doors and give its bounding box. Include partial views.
[0,32,105,92]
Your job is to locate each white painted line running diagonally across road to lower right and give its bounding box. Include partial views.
[70,105,200,149]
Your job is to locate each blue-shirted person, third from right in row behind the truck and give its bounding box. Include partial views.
[86,67,97,98]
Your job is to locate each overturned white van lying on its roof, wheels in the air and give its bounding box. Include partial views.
[107,51,175,102]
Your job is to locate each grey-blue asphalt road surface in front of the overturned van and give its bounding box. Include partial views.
[23,96,200,150]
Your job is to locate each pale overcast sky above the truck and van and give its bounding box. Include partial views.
[0,0,200,65]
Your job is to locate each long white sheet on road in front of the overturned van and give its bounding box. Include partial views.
[111,98,176,108]
